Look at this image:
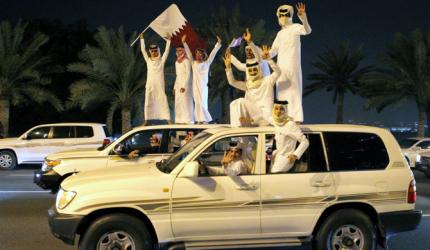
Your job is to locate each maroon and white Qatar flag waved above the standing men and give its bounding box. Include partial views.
[149,4,206,53]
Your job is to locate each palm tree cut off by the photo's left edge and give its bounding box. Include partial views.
[0,21,62,136]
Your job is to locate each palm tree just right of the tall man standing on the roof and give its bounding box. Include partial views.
[304,43,373,123]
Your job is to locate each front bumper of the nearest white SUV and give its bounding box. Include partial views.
[48,206,83,245]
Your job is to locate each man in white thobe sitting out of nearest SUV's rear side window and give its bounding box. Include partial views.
[270,100,309,173]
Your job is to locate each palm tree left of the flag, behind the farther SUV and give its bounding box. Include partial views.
[67,27,146,133]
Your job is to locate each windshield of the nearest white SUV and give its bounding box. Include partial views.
[157,132,211,173]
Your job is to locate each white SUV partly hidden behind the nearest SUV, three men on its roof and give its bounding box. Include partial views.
[33,124,223,193]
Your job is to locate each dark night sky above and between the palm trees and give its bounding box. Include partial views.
[0,0,430,125]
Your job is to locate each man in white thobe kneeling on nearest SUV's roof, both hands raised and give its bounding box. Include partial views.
[224,46,281,127]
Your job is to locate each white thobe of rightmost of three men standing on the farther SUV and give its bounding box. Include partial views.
[184,43,221,122]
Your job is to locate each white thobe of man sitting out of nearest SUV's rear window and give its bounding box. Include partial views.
[270,120,309,173]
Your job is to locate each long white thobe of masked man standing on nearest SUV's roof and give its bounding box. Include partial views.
[270,21,311,122]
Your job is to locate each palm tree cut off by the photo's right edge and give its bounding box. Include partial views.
[362,29,430,136]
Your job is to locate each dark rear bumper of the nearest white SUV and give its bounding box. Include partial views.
[379,210,422,236]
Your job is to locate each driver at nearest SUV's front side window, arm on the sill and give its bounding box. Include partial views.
[206,141,248,176]
